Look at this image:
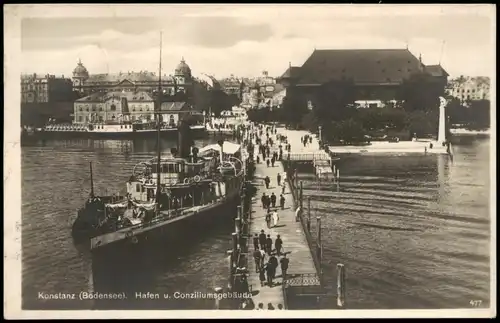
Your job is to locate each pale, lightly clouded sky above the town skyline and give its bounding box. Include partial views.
[15,5,496,78]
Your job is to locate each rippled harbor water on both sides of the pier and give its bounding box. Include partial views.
[22,138,491,309]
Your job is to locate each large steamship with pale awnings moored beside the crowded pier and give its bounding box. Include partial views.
[72,120,244,251]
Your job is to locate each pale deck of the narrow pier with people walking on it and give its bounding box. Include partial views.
[244,162,322,309]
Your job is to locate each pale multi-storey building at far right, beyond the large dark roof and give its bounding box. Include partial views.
[447,76,490,104]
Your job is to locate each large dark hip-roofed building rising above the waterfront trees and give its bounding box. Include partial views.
[279,49,448,109]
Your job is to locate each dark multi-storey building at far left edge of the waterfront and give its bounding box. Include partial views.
[21,74,73,103]
